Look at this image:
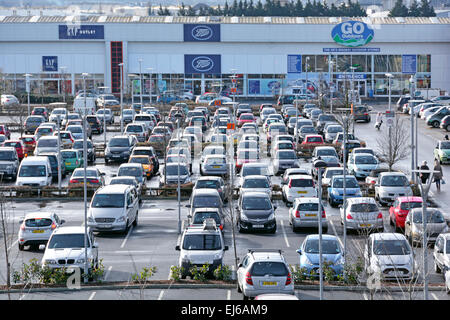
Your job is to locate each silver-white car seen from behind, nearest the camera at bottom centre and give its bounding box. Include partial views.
[237,249,295,300]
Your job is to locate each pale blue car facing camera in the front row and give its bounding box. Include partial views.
[297,234,344,278]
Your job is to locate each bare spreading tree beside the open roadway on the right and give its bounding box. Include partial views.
[377,117,410,171]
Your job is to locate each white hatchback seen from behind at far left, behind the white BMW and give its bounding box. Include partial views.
[18,211,65,251]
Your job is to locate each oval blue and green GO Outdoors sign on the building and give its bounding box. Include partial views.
[331,21,374,47]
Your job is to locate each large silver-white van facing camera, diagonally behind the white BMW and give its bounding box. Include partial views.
[87,184,139,233]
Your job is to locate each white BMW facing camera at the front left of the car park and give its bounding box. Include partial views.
[41,226,99,274]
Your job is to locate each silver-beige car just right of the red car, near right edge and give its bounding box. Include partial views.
[405,208,448,244]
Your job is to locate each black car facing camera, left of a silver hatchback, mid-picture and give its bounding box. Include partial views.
[236,192,277,233]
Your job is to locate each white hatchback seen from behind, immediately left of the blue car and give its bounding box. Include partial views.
[282,174,317,203]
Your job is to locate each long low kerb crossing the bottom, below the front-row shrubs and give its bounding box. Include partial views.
[0,283,446,294]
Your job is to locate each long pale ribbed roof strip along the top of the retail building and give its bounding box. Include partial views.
[0,15,450,25]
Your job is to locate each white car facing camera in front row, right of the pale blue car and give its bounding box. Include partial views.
[364,233,417,280]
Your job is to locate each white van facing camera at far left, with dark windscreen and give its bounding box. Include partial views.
[16,156,52,187]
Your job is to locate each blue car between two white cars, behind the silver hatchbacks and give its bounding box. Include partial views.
[328,175,362,207]
